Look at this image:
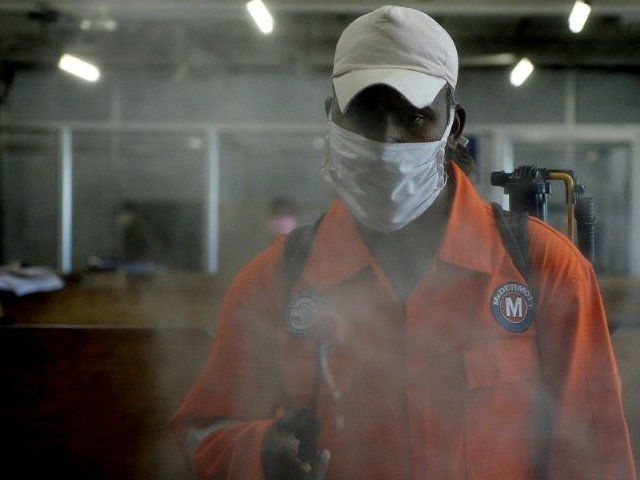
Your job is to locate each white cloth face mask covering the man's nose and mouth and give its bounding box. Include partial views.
[323,111,454,232]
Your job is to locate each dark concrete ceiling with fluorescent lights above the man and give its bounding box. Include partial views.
[0,0,640,78]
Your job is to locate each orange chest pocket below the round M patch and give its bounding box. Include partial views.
[464,336,540,480]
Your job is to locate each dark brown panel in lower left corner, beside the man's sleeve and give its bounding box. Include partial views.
[0,327,211,480]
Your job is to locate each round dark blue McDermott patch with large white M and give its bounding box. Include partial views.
[491,282,534,332]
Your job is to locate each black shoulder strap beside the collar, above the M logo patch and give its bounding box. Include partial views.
[491,202,531,281]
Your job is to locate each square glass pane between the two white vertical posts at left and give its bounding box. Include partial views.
[73,131,206,270]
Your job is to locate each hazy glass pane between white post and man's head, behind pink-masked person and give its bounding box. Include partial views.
[220,132,332,280]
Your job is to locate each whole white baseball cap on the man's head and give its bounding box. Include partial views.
[332,5,458,113]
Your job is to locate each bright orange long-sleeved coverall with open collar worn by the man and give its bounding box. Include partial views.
[171,165,635,480]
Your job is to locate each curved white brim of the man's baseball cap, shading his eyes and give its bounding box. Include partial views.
[333,68,447,113]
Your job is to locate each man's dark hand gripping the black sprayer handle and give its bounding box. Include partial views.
[262,408,329,480]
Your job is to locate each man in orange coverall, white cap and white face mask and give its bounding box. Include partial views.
[172,6,634,480]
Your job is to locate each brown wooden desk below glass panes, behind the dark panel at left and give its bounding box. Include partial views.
[0,272,224,331]
